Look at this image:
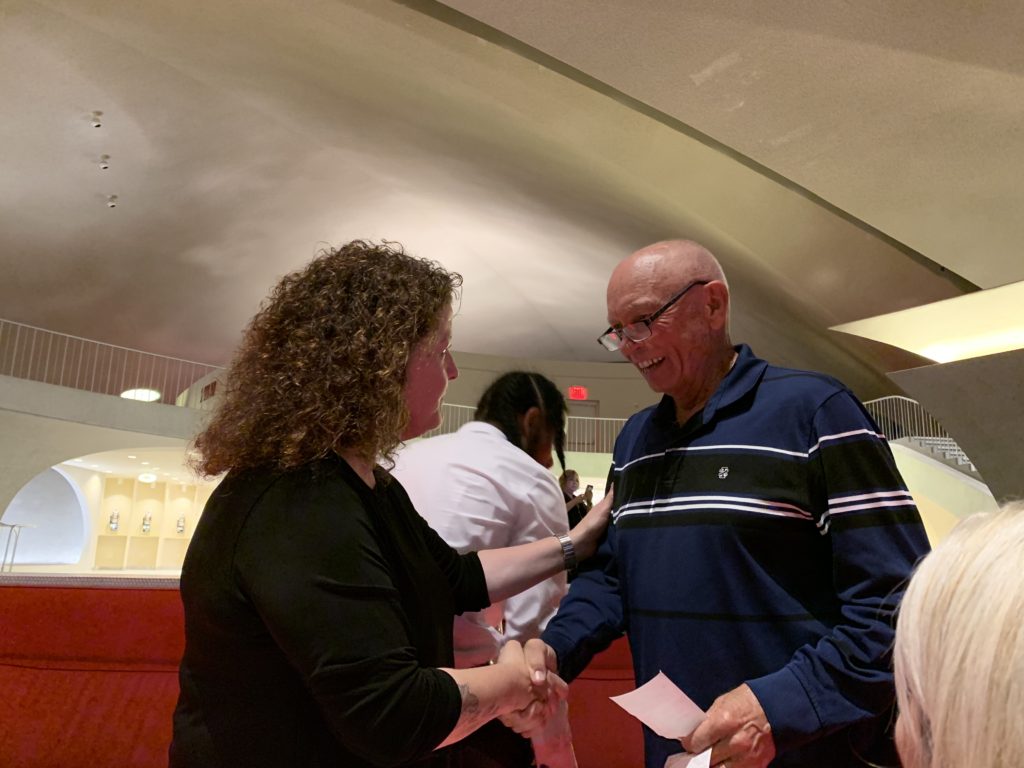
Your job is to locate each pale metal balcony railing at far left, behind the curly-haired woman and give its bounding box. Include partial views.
[0,319,222,408]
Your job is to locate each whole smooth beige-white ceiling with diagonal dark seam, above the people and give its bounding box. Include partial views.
[0,0,1024,396]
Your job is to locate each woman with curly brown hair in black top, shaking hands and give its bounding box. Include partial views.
[170,241,610,768]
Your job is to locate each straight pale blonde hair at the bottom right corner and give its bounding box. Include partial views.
[894,502,1024,768]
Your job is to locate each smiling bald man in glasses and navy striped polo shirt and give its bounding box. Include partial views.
[544,241,928,768]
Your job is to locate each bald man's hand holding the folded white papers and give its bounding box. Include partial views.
[679,683,775,768]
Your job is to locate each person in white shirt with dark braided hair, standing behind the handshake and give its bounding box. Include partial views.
[392,371,568,767]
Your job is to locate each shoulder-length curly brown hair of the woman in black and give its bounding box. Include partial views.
[193,241,462,477]
